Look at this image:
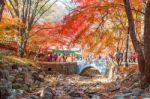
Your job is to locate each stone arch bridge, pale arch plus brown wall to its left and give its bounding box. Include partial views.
[39,60,107,75]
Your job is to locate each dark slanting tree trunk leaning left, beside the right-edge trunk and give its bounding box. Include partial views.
[123,0,145,76]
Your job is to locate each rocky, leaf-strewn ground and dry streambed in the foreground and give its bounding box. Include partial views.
[0,56,150,99]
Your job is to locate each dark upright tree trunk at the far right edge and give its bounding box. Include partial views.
[144,0,150,84]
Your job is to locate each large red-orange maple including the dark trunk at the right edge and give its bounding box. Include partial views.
[58,0,150,83]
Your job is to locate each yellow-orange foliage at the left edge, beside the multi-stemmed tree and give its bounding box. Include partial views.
[0,13,23,51]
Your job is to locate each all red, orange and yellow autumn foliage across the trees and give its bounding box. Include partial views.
[0,0,142,58]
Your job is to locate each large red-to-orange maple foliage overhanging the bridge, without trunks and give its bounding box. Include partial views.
[62,0,141,55]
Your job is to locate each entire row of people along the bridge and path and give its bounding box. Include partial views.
[47,52,138,63]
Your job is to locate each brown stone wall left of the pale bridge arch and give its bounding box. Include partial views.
[39,62,77,74]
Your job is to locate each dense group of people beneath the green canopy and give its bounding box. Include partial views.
[47,53,75,62]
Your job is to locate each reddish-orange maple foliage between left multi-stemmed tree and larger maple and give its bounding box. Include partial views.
[27,22,65,51]
